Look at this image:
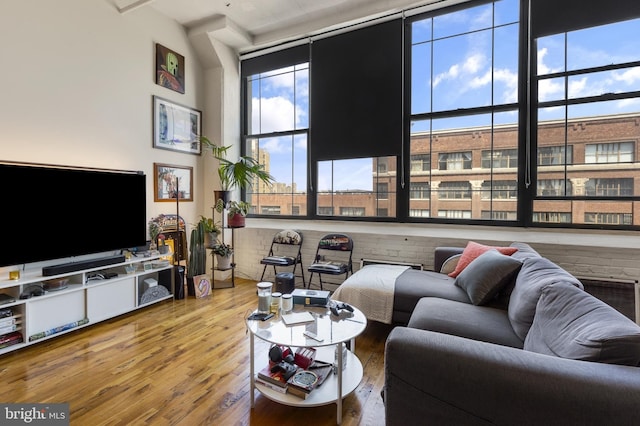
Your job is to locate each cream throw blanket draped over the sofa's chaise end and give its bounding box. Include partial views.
[331,265,409,324]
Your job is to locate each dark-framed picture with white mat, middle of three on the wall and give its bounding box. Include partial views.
[153,96,202,155]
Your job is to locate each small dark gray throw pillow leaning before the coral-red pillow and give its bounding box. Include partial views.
[455,250,522,305]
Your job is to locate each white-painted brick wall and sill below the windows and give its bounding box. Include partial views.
[235,219,640,290]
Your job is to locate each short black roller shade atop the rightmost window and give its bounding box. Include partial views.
[530,0,640,38]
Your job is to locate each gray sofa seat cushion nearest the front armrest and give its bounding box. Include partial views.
[408,297,523,349]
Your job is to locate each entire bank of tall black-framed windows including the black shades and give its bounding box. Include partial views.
[241,0,640,229]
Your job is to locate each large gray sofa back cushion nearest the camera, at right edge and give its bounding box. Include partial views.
[524,282,640,366]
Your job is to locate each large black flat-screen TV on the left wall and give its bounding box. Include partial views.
[0,163,146,266]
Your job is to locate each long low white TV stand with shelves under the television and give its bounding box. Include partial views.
[0,255,174,355]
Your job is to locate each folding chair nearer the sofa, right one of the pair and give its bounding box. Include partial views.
[307,234,353,290]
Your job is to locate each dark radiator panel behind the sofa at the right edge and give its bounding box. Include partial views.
[578,277,640,324]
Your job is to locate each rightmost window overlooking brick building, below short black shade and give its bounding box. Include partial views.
[533,15,640,228]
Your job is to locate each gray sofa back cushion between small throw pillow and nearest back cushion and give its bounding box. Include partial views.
[508,257,583,340]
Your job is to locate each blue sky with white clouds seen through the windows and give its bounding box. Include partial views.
[252,0,640,190]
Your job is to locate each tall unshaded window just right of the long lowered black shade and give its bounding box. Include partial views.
[408,0,520,221]
